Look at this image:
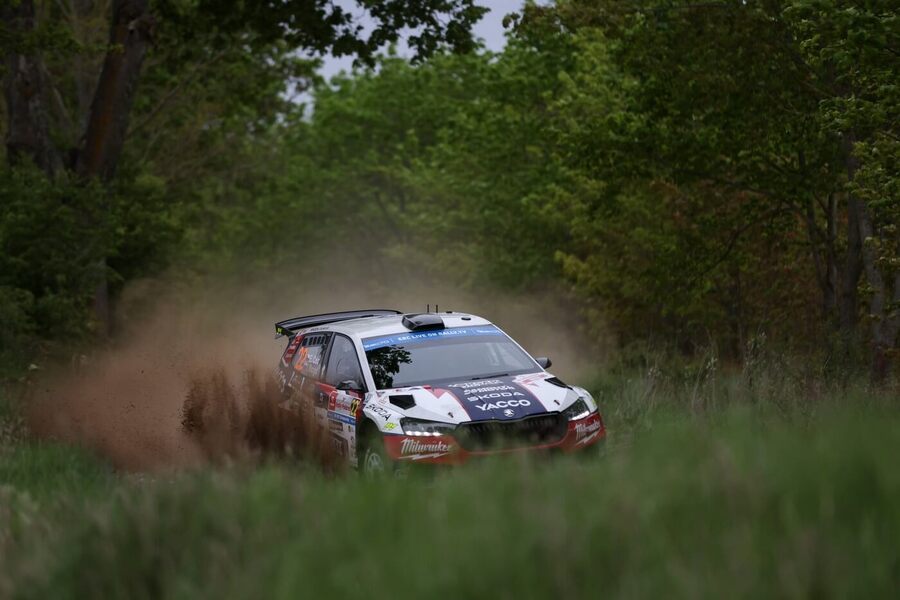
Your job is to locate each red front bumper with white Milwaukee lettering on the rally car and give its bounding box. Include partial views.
[384,412,606,465]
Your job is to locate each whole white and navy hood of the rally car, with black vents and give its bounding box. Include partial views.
[375,371,578,423]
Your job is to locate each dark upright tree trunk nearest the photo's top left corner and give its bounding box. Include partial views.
[0,0,63,177]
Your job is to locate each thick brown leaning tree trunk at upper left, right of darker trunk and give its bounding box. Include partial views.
[75,0,155,335]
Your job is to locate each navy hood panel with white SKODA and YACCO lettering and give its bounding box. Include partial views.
[447,377,546,421]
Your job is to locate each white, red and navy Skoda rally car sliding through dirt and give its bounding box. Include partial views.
[275,310,606,472]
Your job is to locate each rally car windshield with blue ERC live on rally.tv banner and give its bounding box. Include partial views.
[363,325,540,390]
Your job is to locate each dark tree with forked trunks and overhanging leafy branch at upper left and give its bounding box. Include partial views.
[0,0,484,326]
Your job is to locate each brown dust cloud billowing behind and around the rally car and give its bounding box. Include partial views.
[27,270,592,471]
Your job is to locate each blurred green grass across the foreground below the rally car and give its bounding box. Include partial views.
[0,377,900,598]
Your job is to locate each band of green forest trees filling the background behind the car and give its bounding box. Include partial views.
[0,0,900,381]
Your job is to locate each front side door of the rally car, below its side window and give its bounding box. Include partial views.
[321,333,365,463]
